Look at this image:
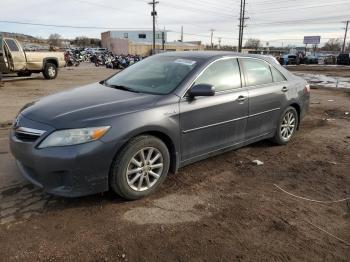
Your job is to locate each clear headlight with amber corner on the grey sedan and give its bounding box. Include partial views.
[39,126,110,148]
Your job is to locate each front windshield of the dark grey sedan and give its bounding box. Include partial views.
[105,55,198,95]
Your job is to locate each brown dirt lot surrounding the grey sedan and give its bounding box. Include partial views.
[0,64,350,261]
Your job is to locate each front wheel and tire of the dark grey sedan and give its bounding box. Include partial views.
[109,135,170,200]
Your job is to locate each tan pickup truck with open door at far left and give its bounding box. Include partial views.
[0,36,65,79]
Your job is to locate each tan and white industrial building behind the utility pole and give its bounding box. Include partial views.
[101,30,204,56]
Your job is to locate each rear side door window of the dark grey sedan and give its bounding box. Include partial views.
[243,58,273,86]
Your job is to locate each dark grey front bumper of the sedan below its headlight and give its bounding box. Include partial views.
[10,114,115,197]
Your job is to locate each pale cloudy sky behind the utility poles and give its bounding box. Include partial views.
[0,0,350,46]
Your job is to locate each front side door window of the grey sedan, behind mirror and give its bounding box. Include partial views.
[195,58,241,92]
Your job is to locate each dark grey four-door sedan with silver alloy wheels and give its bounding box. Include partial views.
[10,51,310,199]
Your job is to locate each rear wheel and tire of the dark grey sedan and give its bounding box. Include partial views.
[272,106,299,145]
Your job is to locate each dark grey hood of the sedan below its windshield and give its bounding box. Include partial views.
[22,83,159,128]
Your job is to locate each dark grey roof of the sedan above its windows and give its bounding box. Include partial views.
[159,51,270,60]
